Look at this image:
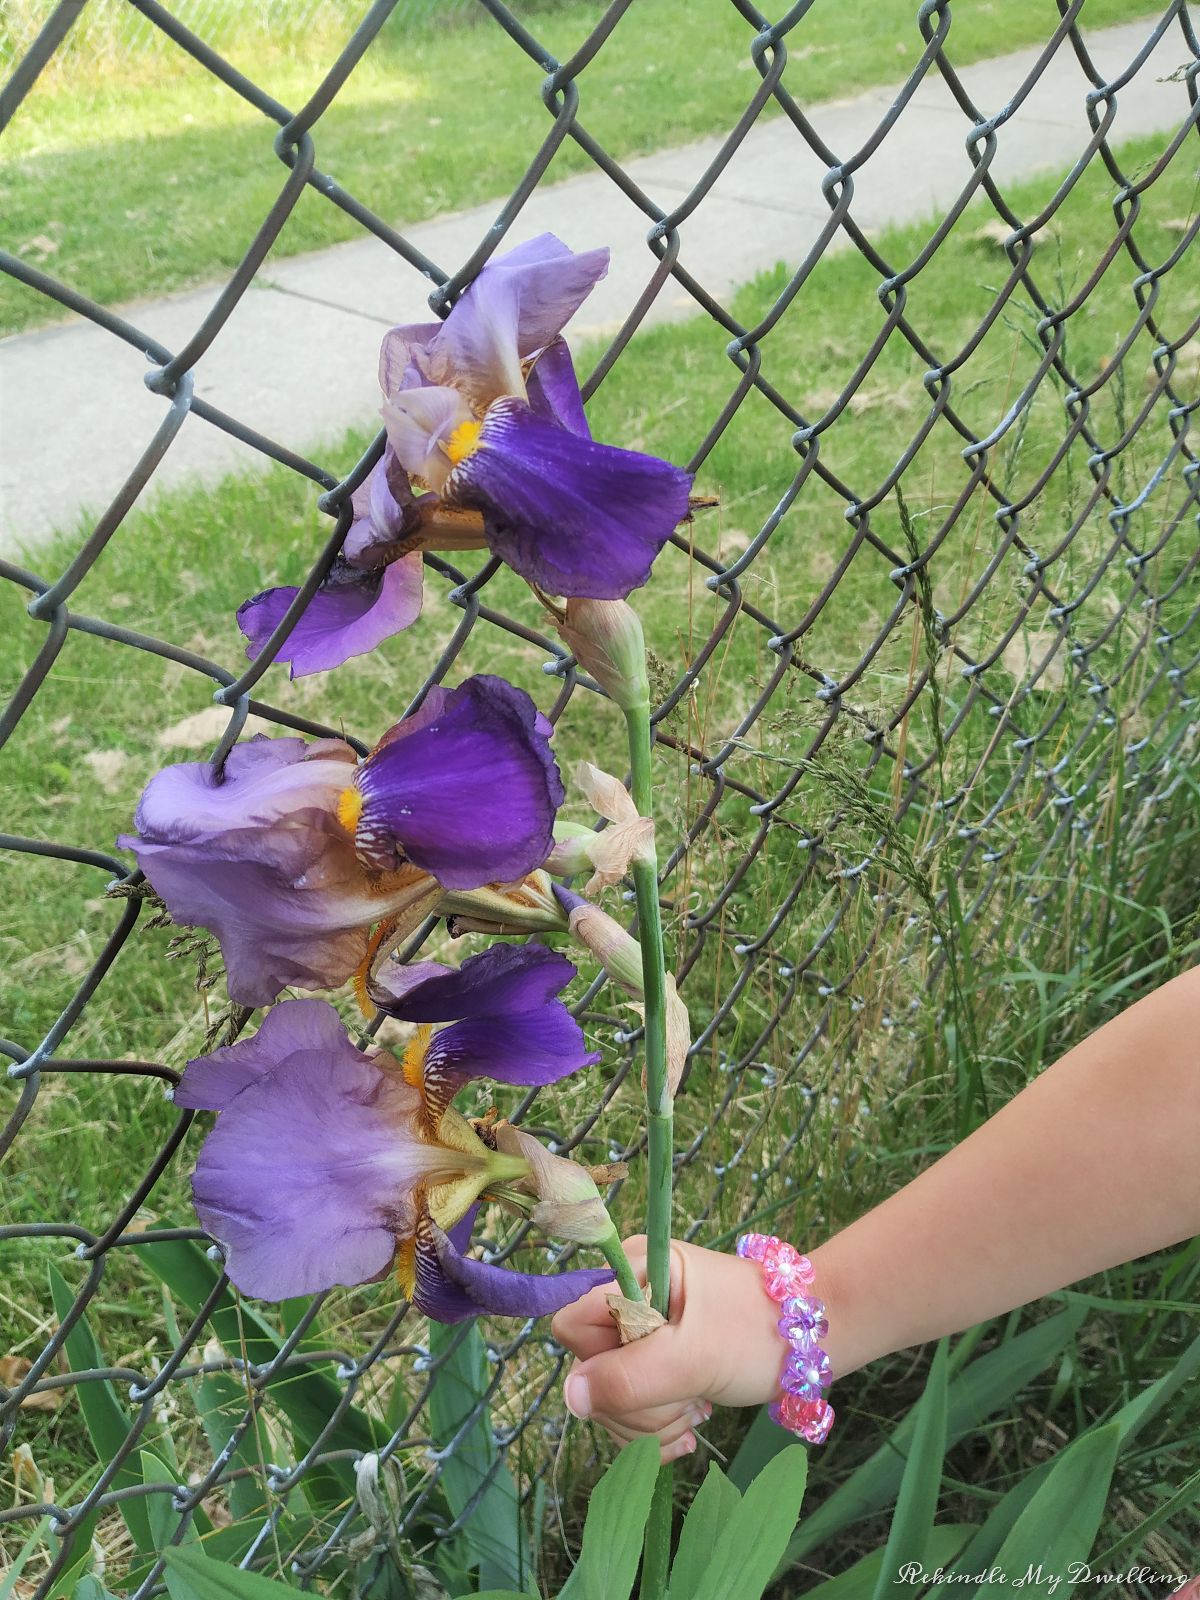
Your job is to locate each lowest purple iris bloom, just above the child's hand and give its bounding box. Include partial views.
[174,946,613,1322]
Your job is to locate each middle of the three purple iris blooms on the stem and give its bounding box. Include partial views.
[118,677,563,1006]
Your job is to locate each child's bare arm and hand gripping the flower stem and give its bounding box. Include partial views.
[554,968,1200,1459]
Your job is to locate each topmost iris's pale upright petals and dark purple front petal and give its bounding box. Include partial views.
[379,234,691,600]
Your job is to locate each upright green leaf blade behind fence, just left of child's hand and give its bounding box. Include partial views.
[429,1322,530,1589]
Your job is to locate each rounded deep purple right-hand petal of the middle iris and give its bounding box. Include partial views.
[355,675,563,890]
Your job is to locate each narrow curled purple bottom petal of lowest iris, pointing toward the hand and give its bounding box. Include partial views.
[413,1222,613,1322]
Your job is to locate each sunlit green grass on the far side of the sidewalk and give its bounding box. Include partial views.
[0,0,1149,333]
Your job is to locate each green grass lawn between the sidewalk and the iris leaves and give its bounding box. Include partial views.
[0,121,1200,1574]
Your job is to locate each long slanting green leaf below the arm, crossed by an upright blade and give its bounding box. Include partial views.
[786,1306,1086,1565]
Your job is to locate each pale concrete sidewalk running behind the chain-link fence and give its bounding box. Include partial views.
[0,22,1189,554]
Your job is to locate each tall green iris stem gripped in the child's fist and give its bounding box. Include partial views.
[626,701,675,1600]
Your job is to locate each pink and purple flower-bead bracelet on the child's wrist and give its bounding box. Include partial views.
[738,1234,834,1445]
